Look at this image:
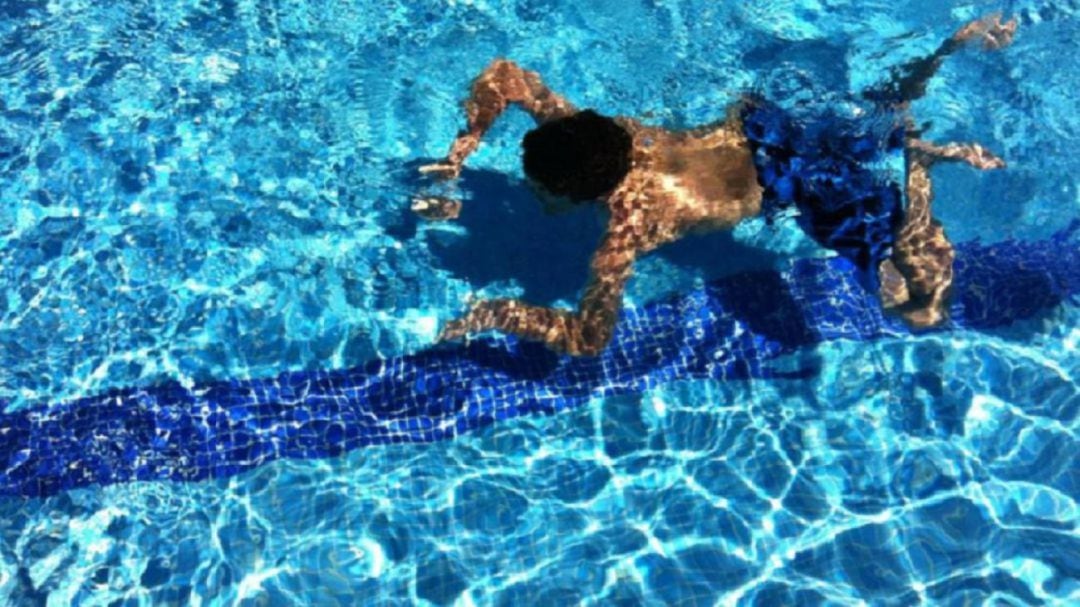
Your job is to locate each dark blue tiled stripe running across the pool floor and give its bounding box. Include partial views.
[0,222,1080,497]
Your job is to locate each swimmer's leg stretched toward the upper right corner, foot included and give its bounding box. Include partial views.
[865,13,1017,106]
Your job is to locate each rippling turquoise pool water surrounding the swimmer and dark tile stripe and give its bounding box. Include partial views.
[0,0,1080,605]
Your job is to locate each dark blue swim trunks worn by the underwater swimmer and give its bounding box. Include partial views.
[741,99,904,288]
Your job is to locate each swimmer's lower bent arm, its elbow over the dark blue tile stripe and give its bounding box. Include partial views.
[440,233,636,355]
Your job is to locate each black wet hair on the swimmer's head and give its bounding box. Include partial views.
[522,109,633,202]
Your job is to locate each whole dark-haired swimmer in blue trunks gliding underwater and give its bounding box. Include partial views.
[413,15,1016,355]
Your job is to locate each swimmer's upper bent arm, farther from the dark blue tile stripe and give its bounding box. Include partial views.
[421,59,577,177]
